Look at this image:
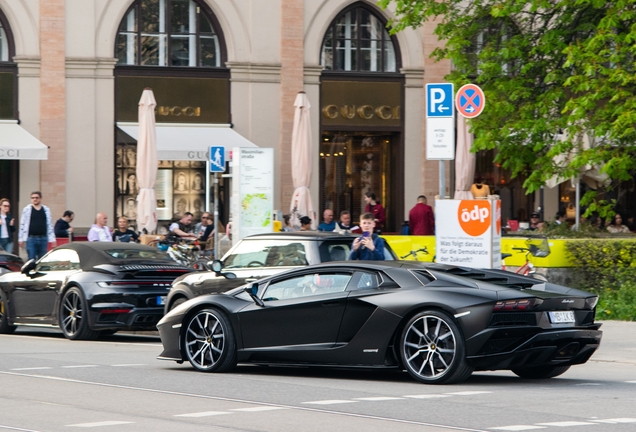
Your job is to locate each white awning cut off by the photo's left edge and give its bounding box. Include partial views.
[0,120,49,160]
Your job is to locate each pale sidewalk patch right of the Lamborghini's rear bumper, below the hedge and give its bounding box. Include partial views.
[590,321,636,365]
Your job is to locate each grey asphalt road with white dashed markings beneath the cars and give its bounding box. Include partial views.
[0,321,636,432]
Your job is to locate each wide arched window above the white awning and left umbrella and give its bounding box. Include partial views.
[115,0,225,67]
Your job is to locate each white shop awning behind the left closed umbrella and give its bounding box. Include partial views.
[117,122,258,161]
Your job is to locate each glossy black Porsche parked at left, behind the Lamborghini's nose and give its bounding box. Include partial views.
[0,242,191,339]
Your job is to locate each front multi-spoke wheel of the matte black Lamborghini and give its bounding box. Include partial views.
[183,309,236,372]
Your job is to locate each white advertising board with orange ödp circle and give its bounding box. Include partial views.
[435,199,501,268]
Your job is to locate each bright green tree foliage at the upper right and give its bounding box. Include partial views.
[379,0,636,214]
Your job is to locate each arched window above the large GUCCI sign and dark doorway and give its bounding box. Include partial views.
[320,5,398,72]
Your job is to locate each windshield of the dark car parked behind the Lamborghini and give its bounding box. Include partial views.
[223,240,309,269]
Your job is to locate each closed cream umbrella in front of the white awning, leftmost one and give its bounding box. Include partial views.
[137,88,158,233]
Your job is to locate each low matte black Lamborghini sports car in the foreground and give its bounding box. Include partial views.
[157,261,601,384]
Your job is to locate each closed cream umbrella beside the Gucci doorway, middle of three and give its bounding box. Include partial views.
[289,91,316,229]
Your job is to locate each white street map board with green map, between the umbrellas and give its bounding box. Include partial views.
[232,147,274,244]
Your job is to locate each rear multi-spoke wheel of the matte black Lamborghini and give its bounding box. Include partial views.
[400,311,472,384]
